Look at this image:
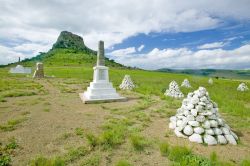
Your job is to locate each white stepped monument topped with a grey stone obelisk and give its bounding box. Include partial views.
[79,41,126,103]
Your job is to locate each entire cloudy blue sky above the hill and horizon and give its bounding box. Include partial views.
[0,0,250,70]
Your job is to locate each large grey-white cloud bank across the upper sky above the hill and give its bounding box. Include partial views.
[0,0,250,62]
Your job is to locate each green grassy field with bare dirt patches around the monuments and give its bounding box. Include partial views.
[0,65,250,166]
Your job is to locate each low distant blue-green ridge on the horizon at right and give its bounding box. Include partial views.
[157,68,250,79]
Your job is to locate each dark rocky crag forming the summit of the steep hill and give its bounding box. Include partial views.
[52,31,96,54]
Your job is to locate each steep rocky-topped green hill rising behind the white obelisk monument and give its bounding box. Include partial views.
[6,31,125,67]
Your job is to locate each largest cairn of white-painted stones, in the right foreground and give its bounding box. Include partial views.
[169,87,238,145]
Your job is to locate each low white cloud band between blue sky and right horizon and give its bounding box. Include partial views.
[111,45,250,69]
